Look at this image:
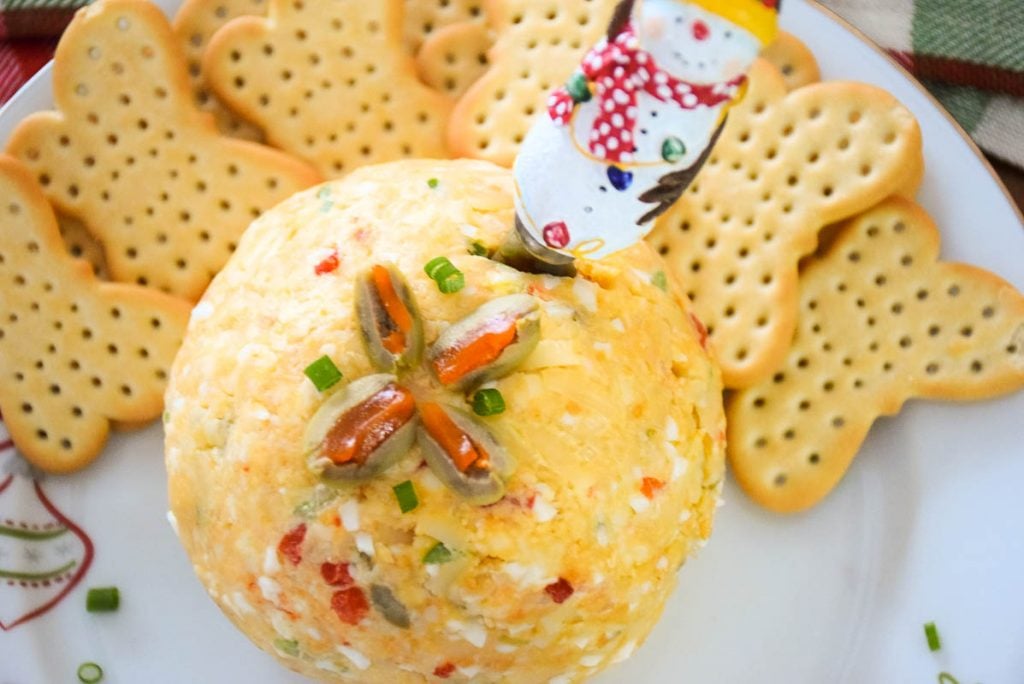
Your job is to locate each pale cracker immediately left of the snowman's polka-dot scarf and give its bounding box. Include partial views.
[447,0,618,166]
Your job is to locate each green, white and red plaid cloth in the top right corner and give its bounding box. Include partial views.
[823,0,1024,168]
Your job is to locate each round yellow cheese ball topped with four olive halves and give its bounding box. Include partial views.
[165,161,725,684]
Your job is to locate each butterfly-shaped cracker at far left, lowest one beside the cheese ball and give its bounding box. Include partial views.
[0,155,189,472]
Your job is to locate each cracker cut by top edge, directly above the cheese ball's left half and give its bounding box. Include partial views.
[203,0,452,176]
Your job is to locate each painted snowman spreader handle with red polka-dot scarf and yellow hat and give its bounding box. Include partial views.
[515,0,778,261]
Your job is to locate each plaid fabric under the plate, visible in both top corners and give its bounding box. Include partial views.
[0,0,1024,167]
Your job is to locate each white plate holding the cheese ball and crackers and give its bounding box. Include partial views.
[0,0,1024,684]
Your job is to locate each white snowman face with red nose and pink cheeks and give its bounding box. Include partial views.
[640,0,761,83]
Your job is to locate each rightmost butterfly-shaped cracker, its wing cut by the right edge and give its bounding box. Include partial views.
[727,194,1024,512]
